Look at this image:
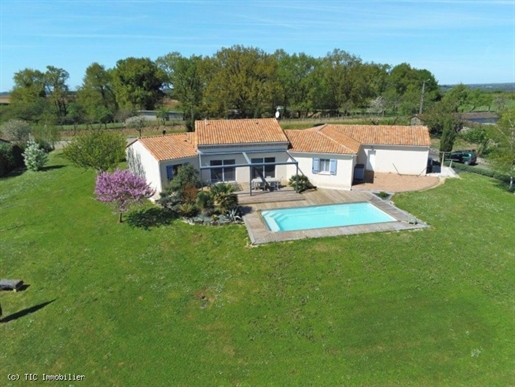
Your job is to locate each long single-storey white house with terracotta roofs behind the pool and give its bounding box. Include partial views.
[127,118,430,197]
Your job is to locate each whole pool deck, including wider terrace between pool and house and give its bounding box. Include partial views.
[240,189,429,245]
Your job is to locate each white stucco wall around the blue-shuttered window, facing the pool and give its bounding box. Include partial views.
[288,153,355,190]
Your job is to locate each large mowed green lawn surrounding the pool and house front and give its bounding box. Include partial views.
[0,155,515,386]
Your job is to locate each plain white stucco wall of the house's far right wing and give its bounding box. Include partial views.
[357,145,429,175]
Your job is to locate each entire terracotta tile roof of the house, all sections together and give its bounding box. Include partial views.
[137,123,431,160]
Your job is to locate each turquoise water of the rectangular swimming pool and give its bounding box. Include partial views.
[261,202,396,231]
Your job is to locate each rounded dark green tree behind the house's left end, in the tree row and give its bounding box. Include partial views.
[113,58,166,110]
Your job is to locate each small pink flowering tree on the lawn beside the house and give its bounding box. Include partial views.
[95,169,155,223]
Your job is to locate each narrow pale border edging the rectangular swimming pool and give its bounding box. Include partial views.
[243,192,429,245]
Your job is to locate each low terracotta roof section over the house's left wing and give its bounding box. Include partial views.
[137,133,198,160]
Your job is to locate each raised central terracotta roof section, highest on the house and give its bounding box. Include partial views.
[195,118,288,146]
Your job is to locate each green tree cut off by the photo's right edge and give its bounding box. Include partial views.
[491,110,515,190]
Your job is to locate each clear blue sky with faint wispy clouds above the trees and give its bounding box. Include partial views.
[0,0,515,91]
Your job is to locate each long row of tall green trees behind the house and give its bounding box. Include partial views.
[5,46,441,130]
